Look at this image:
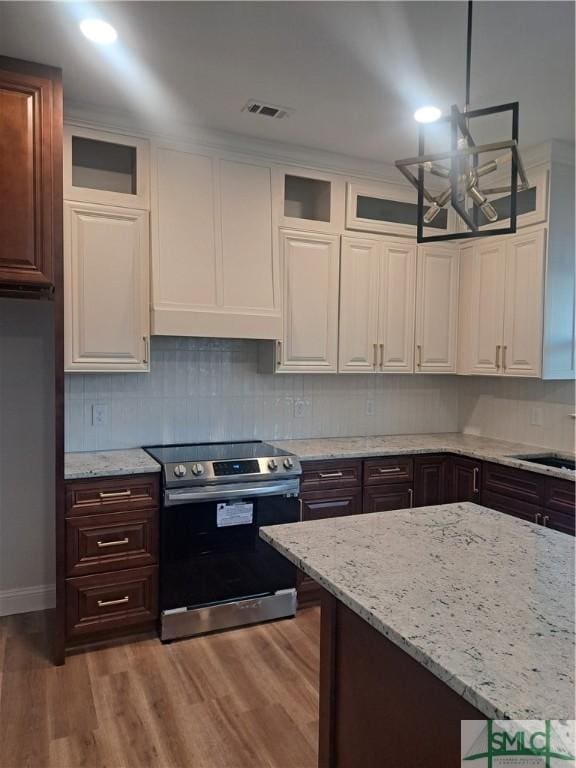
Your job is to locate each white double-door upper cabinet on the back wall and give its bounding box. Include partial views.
[339,237,416,373]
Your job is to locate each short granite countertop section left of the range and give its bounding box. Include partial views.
[64,448,160,480]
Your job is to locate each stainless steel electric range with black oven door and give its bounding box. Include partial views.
[145,441,302,641]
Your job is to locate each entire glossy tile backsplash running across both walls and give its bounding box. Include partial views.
[66,336,575,451]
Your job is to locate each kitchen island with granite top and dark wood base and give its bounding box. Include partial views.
[261,503,574,768]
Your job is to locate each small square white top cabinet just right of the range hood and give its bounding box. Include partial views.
[274,167,345,234]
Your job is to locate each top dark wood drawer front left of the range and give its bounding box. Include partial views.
[66,475,160,516]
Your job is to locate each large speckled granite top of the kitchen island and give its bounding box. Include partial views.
[260,503,574,719]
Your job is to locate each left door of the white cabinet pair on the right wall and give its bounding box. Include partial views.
[459,238,506,375]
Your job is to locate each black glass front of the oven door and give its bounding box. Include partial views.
[160,496,298,610]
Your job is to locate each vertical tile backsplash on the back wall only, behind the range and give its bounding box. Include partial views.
[66,337,458,451]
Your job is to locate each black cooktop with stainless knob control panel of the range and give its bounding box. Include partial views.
[145,441,302,487]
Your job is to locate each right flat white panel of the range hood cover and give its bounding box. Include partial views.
[220,160,280,314]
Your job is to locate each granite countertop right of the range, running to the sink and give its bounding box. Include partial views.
[270,432,576,480]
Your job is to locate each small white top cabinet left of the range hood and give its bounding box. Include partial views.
[64,125,149,209]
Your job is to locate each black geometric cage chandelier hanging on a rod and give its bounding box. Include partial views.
[396,0,529,243]
